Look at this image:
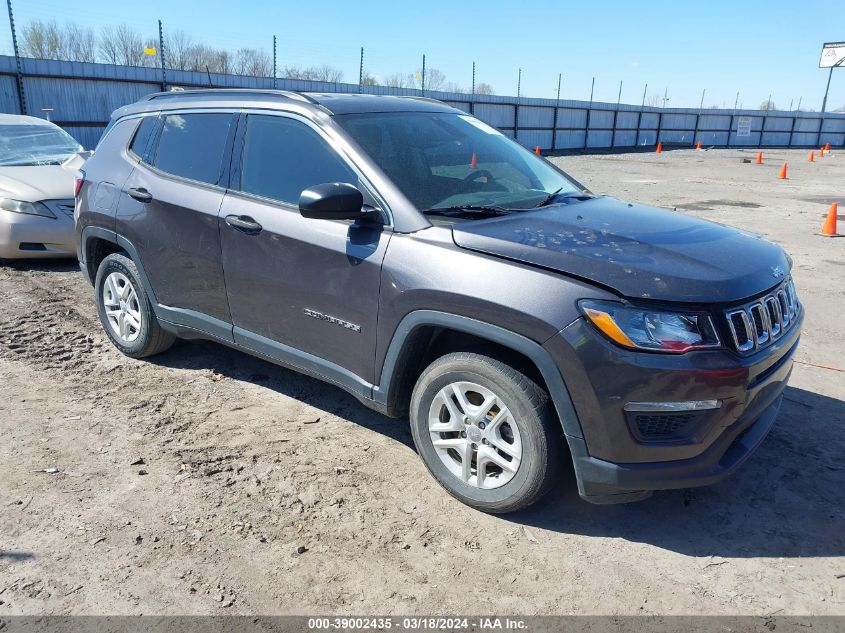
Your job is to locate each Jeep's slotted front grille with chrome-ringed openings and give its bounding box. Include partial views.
[725,279,801,353]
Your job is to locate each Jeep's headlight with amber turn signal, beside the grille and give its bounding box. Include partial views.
[578,301,719,354]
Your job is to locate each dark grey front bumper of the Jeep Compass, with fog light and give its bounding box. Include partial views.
[544,312,803,503]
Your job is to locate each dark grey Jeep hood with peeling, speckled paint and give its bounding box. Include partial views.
[452,197,790,303]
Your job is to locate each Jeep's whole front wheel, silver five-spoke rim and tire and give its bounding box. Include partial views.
[410,352,563,513]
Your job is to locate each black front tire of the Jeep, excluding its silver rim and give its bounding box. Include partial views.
[410,352,563,514]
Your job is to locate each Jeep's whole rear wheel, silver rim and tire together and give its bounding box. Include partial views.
[94,253,175,358]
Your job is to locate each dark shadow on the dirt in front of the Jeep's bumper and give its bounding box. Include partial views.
[505,387,845,564]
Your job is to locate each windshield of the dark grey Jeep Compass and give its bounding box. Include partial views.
[334,112,582,210]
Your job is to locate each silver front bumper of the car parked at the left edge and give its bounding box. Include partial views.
[0,210,76,259]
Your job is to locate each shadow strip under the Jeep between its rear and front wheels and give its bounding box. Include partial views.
[152,340,414,450]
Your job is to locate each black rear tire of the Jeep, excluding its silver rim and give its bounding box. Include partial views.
[94,253,176,358]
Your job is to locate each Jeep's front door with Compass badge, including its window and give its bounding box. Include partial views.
[220,114,390,390]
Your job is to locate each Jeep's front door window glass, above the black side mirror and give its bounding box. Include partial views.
[241,115,358,204]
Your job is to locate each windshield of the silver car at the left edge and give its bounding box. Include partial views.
[0,124,82,167]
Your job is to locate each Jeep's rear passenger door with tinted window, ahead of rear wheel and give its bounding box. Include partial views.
[116,111,237,340]
